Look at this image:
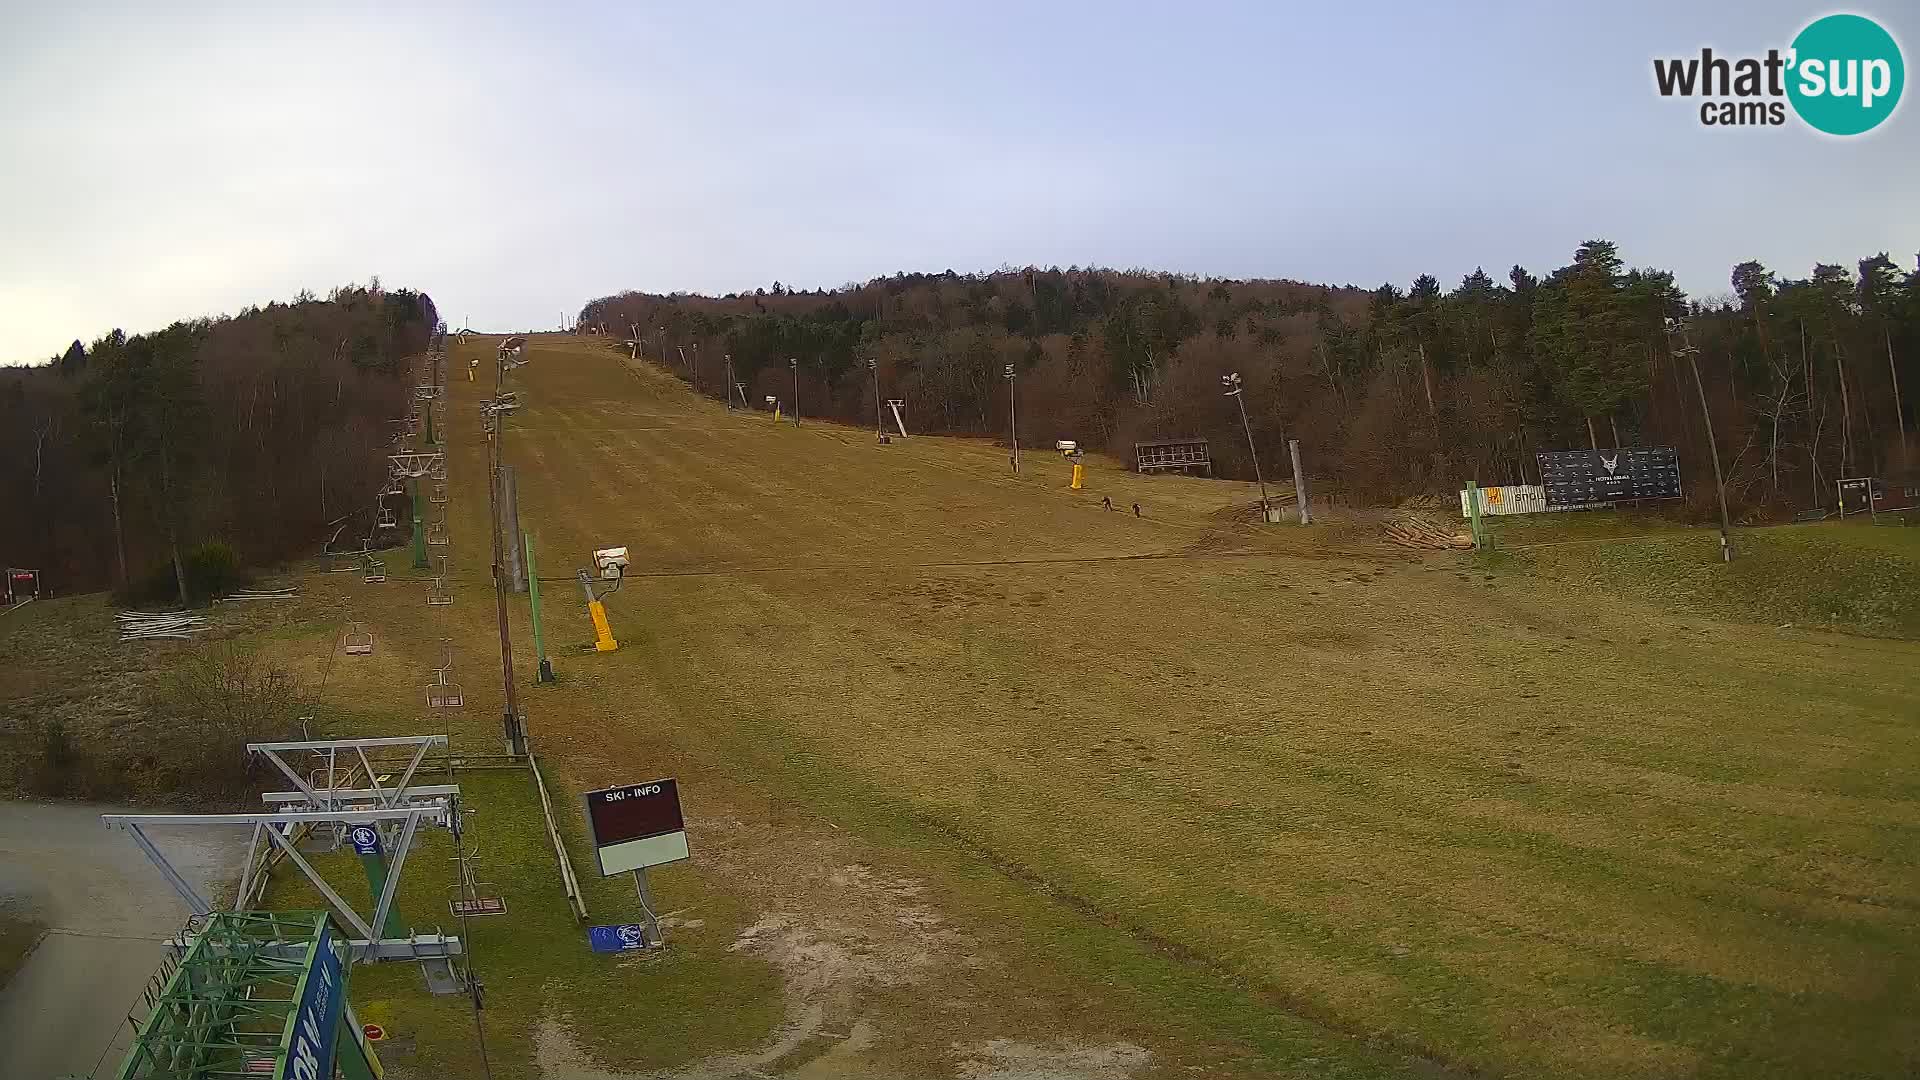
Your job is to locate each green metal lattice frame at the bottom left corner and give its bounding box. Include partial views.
[119,911,351,1080]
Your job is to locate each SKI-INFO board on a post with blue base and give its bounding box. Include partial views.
[586,778,691,951]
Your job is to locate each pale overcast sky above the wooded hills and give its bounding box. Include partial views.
[0,0,1920,363]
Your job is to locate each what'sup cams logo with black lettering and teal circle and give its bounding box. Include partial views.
[1653,15,1907,135]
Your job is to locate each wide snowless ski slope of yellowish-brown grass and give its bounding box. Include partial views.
[408,336,1920,1078]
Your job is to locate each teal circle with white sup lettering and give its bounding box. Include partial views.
[1788,15,1907,135]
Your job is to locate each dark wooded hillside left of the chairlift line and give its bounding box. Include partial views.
[0,281,438,592]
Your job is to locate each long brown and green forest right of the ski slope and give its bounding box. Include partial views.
[580,240,1920,513]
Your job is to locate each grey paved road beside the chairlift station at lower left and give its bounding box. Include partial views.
[0,801,246,1080]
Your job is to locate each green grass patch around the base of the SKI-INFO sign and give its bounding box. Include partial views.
[269,769,781,1080]
